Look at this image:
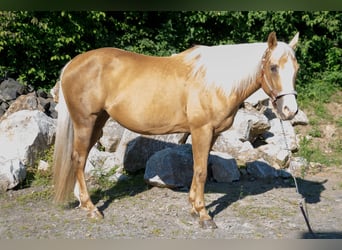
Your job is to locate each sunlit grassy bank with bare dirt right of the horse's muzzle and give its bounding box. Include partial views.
[296,76,342,170]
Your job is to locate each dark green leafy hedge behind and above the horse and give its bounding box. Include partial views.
[0,11,342,93]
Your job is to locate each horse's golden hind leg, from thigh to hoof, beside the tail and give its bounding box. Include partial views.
[72,112,108,218]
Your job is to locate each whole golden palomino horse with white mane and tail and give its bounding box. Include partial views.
[54,32,298,228]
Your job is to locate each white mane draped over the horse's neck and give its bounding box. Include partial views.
[185,43,267,95]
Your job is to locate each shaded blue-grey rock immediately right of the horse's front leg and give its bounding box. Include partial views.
[208,152,240,182]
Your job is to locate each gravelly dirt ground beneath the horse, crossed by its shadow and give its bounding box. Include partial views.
[0,168,342,239]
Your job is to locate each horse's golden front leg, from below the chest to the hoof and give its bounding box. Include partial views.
[189,126,217,228]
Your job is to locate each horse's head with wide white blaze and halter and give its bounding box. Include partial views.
[261,32,299,120]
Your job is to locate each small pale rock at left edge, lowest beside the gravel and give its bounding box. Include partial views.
[0,157,26,192]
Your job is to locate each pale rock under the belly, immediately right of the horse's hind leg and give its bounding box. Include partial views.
[99,118,125,152]
